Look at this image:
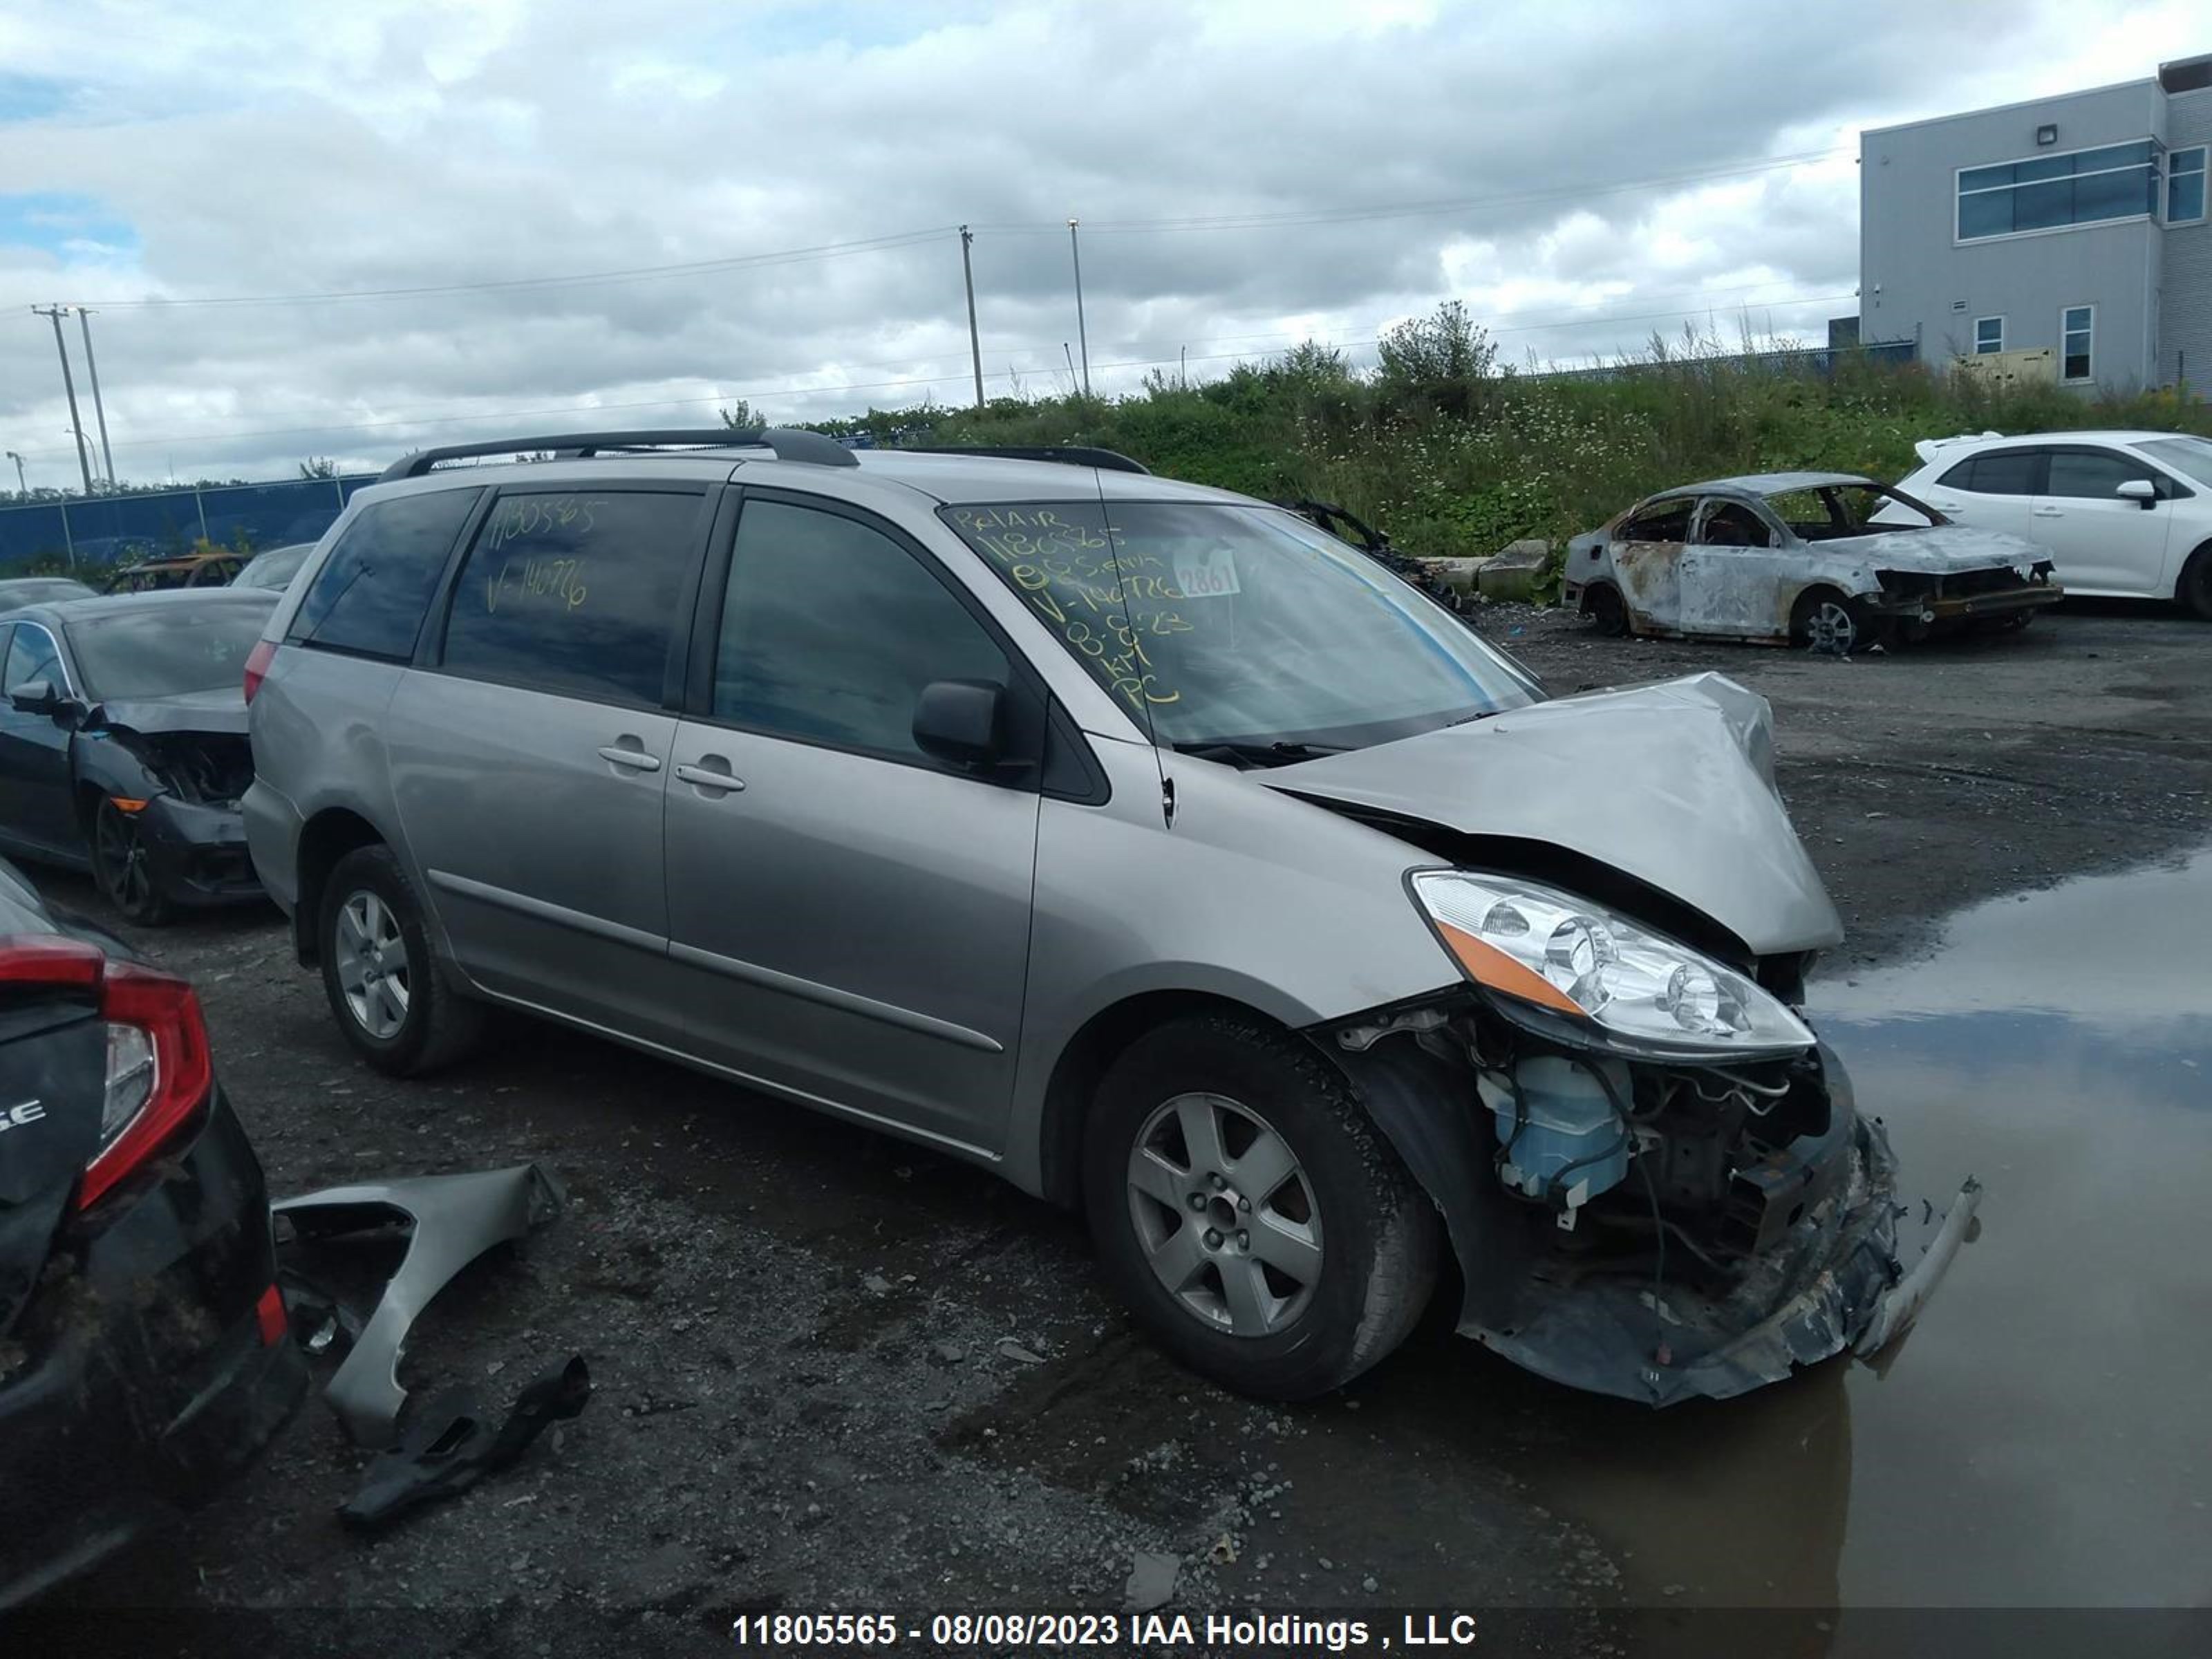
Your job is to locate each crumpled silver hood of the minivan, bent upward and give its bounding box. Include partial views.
[1254,675,1843,955]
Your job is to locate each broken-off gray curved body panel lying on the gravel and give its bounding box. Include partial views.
[270,1163,566,1447]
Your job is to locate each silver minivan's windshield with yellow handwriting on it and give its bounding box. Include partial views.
[942,502,1539,759]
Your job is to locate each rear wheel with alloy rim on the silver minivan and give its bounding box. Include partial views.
[319,847,482,1077]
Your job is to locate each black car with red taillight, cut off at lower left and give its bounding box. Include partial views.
[0,861,308,1611]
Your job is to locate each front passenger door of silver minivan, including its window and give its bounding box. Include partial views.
[668,494,1042,1152]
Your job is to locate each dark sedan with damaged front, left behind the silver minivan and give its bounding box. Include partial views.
[0,588,276,925]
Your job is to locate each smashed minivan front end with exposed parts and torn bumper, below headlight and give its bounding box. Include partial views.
[1331,997,1978,1405]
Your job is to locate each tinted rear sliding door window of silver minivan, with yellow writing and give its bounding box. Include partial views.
[444,489,701,708]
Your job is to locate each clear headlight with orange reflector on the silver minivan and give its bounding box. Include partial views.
[1412,870,1814,1060]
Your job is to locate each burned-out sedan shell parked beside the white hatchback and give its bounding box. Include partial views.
[1564,474,2064,653]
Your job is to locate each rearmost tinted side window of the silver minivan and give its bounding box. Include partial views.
[288,489,485,662]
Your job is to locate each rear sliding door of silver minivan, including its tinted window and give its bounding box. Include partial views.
[383,485,708,1047]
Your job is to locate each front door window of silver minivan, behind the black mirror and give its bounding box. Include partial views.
[712,502,1011,765]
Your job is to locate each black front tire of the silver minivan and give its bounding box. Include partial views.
[1084,1015,1442,1400]
